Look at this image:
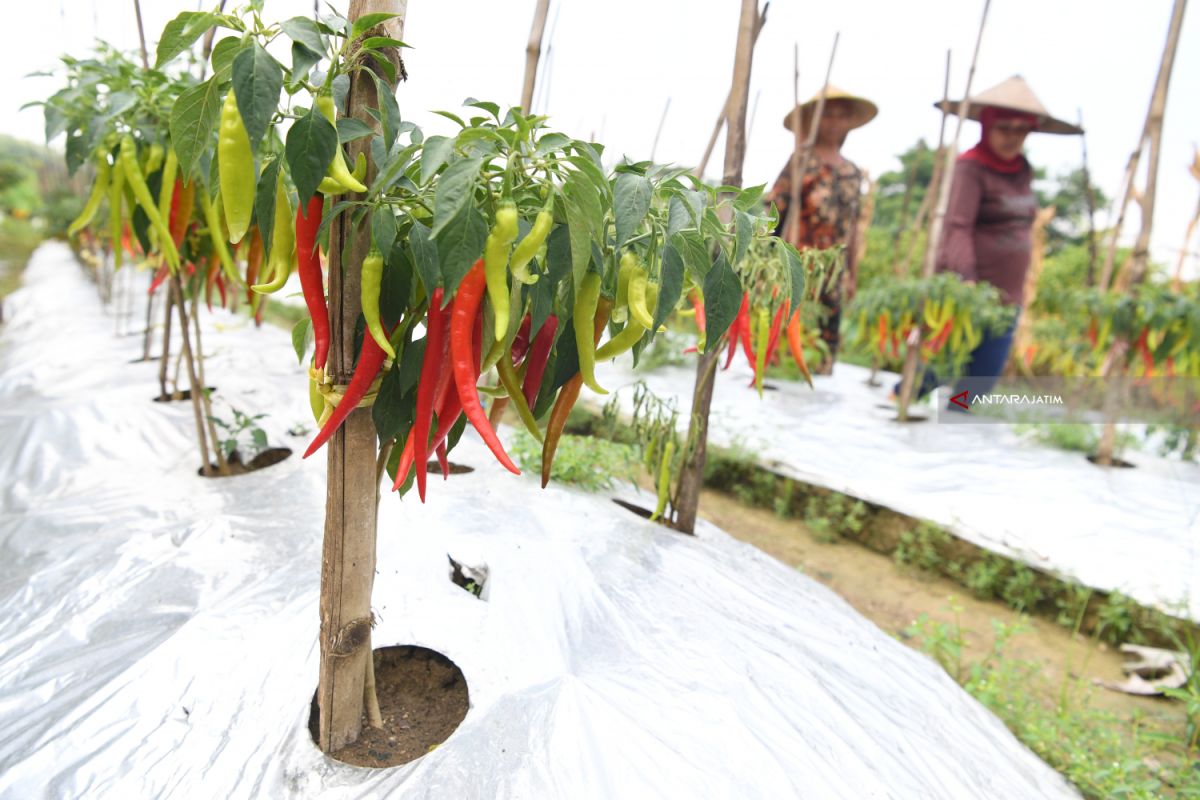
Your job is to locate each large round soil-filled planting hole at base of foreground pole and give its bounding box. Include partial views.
[308,644,470,769]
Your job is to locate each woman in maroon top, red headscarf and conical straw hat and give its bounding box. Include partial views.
[902,76,1084,410]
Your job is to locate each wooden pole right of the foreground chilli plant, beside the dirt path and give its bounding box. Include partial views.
[672,0,766,534]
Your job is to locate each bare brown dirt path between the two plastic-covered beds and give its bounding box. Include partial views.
[700,491,1184,733]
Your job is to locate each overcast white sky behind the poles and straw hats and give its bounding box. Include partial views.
[9,0,1200,280]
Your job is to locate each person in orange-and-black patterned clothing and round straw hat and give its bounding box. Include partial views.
[766,84,878,374]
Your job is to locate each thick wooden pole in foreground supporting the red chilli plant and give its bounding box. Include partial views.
[317,0,408,752]
